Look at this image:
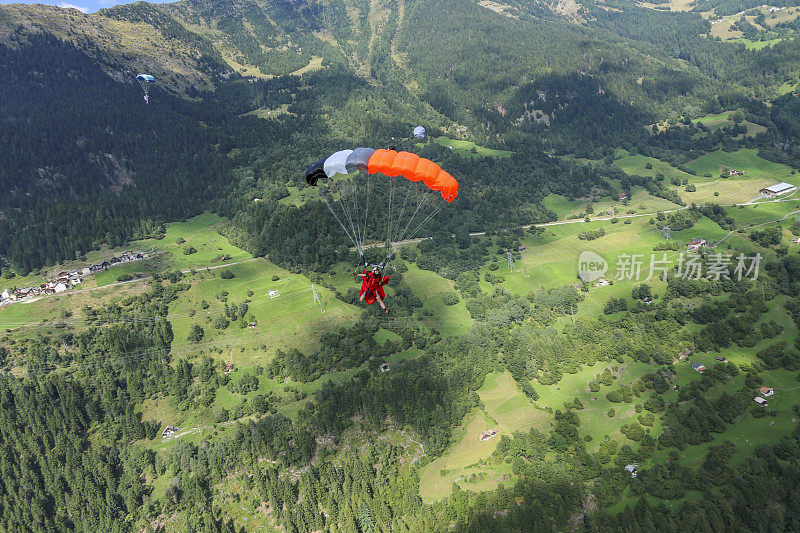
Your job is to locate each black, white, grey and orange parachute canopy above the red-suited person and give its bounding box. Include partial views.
[306,148,458,202]
